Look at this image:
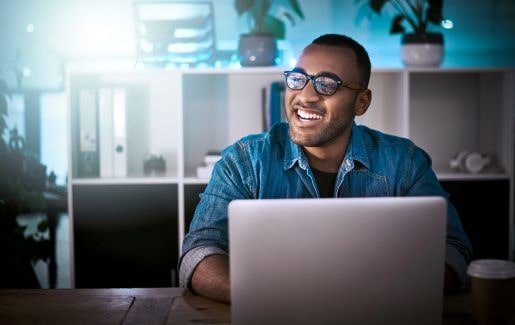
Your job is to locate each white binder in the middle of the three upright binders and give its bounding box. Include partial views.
[98,88,114,177]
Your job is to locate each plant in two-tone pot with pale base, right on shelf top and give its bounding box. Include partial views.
[367,0,444,66]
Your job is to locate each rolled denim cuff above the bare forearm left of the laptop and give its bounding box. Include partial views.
[179,246,229,291]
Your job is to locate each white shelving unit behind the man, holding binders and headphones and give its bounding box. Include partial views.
[68,67,515,286]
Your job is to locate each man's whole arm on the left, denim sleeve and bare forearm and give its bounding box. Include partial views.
[179,142,257,303]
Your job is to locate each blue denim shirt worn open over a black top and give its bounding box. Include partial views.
[179,123,472,287]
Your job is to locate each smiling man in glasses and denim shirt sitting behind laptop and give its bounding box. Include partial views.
[179,34,472,303]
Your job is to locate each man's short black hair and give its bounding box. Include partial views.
[311,34,372,87]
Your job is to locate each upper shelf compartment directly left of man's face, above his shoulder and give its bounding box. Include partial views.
[183,69,283,177]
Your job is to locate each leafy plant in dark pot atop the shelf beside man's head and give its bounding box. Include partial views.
[234,0,304,66]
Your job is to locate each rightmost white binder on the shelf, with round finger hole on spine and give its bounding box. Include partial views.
[113,88,127,177]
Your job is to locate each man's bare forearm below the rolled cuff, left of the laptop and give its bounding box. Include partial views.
[191,255,231,304]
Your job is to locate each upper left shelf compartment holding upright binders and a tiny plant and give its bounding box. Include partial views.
[69,71,181,178]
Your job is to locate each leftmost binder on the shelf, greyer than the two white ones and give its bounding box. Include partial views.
[78,89,99,177]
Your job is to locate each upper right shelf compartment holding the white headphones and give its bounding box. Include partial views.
[409,70,512,174]
